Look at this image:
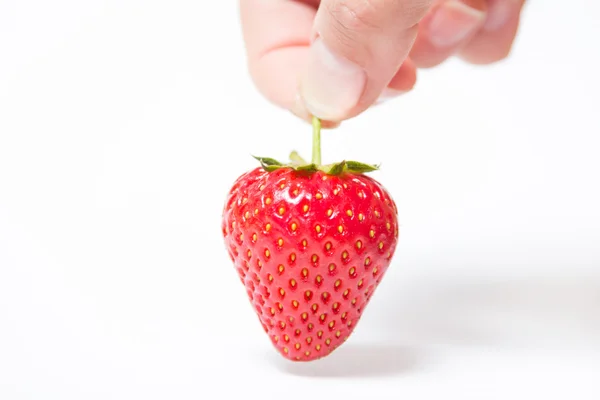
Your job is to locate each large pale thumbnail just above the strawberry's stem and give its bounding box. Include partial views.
[300,37,367,121]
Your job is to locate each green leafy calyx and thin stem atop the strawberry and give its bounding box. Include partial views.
[254,117,379,175]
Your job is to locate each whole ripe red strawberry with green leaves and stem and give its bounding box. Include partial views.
[222,119,398,361]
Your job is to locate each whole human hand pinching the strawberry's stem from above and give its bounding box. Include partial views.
[240,0,525,127]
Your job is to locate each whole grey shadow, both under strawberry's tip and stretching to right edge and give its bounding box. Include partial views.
[278,270,600,377]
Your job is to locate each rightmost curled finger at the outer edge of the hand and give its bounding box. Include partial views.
[459,0,525,64]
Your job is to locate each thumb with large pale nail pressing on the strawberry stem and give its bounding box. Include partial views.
[299,0,433,121]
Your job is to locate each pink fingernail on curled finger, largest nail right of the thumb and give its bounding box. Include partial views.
[429,0,485,47]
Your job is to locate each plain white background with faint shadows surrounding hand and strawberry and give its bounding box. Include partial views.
[0,0,600,400]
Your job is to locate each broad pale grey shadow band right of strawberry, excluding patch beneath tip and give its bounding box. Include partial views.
[374,276,600,348]
